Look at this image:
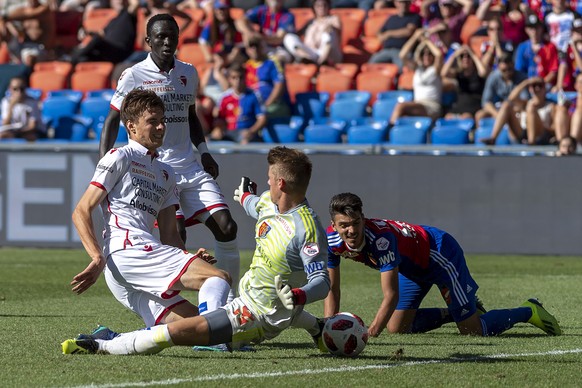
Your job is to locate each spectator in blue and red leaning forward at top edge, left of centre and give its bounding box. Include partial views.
[237,0,295,63]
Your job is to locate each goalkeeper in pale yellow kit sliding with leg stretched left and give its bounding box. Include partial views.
[62,147,329,354]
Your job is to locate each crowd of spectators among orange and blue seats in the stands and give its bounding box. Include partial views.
[0,0,582,154]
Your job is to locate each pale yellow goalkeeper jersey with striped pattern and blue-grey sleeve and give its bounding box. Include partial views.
[239,191,329,314]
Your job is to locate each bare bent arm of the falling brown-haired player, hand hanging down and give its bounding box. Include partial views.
[71,185,109,294]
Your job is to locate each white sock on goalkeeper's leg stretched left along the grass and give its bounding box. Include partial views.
[96,325,174,354]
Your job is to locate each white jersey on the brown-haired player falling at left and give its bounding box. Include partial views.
[91,140,178,257]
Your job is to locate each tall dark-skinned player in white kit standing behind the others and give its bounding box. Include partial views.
[99,14,240,306]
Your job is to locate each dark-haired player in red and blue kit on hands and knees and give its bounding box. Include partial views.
[325,193,562,337]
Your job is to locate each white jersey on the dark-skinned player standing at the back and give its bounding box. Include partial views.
[111,54,202,173]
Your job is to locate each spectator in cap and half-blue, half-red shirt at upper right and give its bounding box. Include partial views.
[515,14,559,87]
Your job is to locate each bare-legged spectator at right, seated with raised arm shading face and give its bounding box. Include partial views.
[481,77,556,145]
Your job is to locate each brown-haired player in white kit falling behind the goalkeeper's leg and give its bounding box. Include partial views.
[71,90,230,326]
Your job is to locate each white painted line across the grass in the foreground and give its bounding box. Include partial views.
[67,349,582,388]
